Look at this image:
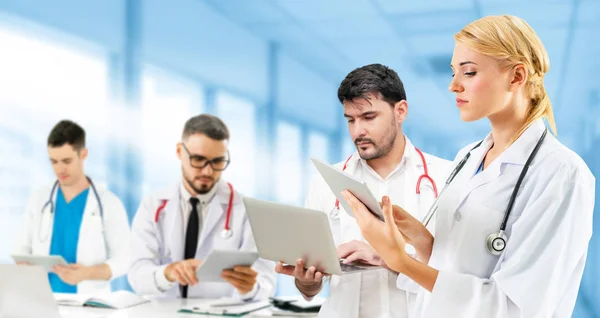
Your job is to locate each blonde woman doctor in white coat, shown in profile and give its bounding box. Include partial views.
[345,15,595,318]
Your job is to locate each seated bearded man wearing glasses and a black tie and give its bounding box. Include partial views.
[128,114,275,300]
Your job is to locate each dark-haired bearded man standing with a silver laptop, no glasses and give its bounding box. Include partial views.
[276,64,450,318]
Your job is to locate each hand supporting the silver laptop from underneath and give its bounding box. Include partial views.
[275,259,325,299]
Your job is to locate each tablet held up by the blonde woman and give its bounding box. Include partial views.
[310,158,383,221]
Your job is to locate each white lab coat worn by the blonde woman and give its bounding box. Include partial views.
[415,120,595,318]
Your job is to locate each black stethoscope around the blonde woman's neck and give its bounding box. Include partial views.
[423,129,548,256]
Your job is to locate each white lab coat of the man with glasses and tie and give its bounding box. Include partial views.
[128,180,275,299]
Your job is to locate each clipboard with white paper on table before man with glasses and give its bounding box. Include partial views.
[179,300,271,317]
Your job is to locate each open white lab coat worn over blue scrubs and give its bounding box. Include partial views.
[13,183,130,294]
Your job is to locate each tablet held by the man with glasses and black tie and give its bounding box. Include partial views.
[196,250,258,282]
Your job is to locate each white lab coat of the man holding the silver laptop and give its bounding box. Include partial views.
[305,138,450,318]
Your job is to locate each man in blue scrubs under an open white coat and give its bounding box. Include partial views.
[13,120,130,293]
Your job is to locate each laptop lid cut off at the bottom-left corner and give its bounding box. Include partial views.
[0,265,61,318]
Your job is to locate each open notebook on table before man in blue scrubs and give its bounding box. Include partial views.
[54,290,149,309]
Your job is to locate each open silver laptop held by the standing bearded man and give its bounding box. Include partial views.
[244,198,381,275]
